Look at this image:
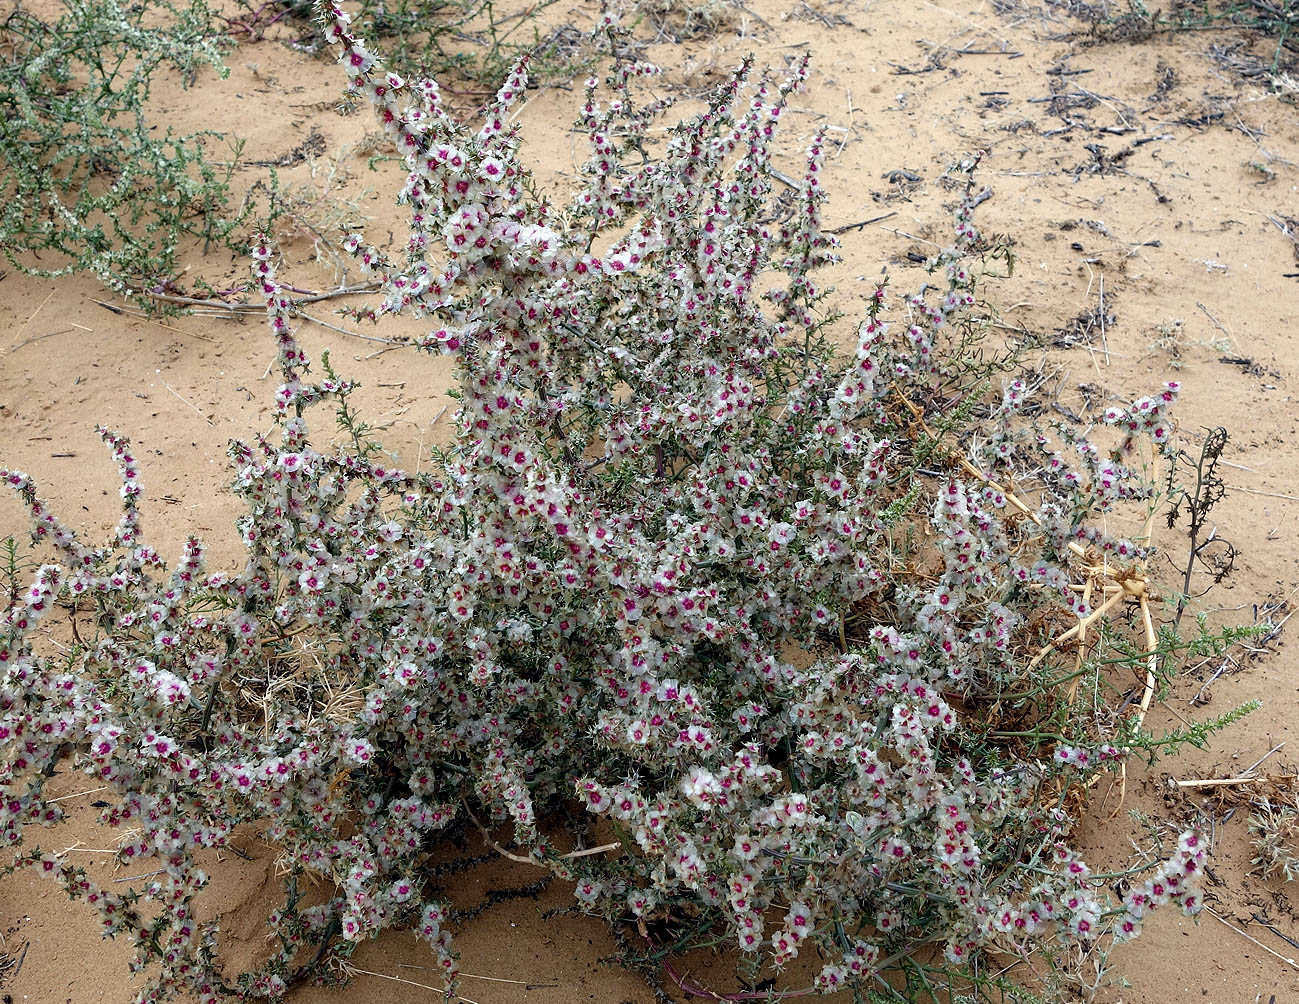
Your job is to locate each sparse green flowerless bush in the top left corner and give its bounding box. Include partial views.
[0,0,250,291]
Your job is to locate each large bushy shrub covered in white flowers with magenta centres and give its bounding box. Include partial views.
[0,5,1204,1001]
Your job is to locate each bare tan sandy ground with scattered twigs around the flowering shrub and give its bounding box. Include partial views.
[0,0,1299,1004]
